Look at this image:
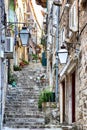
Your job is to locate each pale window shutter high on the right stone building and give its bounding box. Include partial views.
[69,0,78,32]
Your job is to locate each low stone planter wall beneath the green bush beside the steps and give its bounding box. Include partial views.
[42,102,60,126]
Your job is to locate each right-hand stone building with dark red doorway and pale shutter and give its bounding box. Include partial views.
[59,0,87,130]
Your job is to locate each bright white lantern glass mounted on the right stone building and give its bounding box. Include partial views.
[58,49,68,64]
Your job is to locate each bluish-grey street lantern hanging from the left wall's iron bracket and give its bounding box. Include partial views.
[20,27,29,46]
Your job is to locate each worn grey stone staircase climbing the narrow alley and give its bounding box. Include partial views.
[4,63,45,128]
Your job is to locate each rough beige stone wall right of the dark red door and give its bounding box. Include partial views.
[76,3,87,130]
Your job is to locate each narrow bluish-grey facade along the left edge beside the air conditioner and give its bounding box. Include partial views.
[0,0,8,129]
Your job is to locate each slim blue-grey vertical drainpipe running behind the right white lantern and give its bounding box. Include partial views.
[55,6,60,103]
